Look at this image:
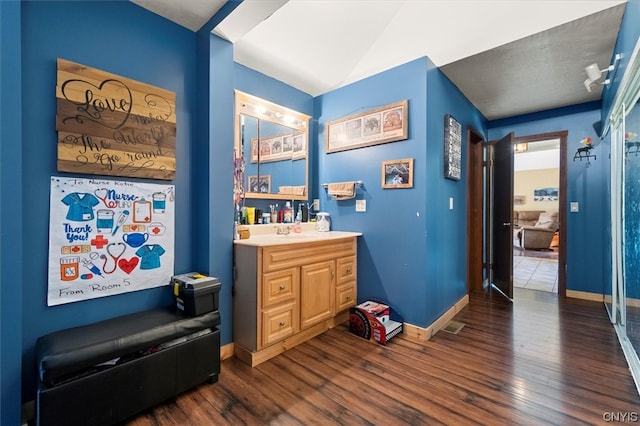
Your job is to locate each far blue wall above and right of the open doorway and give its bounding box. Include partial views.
[489,107,611,294]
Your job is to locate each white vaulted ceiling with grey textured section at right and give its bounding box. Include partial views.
[131,0,624,120]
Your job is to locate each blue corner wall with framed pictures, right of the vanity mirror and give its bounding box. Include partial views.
[315,58,483,326]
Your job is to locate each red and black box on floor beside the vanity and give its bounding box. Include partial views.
[349,300,403,345]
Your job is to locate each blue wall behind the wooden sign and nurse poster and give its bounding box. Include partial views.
[16,1,196,399]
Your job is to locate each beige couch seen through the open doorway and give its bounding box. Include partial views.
[513,210,560,250]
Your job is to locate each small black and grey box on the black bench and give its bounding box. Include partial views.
[171,272,222,316]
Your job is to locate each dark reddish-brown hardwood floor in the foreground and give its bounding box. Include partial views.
[127,288,640,426]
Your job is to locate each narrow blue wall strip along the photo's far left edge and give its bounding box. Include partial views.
[0,1,23,425]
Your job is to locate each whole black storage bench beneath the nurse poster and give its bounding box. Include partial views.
[35,307,220,426]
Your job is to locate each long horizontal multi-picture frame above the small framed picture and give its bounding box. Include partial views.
[325,99,409,154]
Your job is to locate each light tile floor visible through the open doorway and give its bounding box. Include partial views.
[513,256,558,293]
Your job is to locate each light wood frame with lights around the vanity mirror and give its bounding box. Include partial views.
[234,90,311,200]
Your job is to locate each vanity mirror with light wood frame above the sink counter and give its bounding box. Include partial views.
[235,90,310,200]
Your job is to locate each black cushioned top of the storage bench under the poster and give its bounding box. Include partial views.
[35,307,220,383]
